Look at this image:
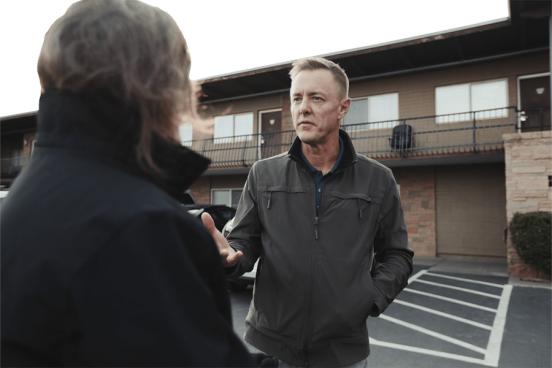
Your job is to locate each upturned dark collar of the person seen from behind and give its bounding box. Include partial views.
[36,89,210,199]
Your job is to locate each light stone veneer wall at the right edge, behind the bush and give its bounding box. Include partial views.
[503,131,552,279]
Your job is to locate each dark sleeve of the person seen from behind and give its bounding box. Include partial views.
[68,212,253,367]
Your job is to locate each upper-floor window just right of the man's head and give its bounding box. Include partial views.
[343,93,399,129]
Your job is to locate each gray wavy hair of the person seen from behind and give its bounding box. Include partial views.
[38,0,195,173]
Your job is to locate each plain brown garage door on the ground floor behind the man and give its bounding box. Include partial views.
[435,164,506,257]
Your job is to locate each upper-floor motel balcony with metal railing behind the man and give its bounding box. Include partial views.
[184,107,522,169]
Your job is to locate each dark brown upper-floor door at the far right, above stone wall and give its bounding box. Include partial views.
[519,76,550,132]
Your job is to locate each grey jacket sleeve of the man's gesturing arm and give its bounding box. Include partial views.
[227,163,262,277]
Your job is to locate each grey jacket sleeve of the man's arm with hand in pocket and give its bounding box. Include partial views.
[370,173,414,316]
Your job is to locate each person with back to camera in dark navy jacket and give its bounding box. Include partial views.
[1,0,272,367]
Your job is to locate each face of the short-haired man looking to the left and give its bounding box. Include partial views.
[290,69,350,145]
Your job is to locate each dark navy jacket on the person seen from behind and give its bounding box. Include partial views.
[1,90,251,367]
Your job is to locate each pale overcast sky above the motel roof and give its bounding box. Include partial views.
[0,0,509,117]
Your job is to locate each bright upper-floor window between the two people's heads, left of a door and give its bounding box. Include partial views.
[214,112,253,143]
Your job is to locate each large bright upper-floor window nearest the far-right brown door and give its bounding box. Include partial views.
[435,79,508,123]
